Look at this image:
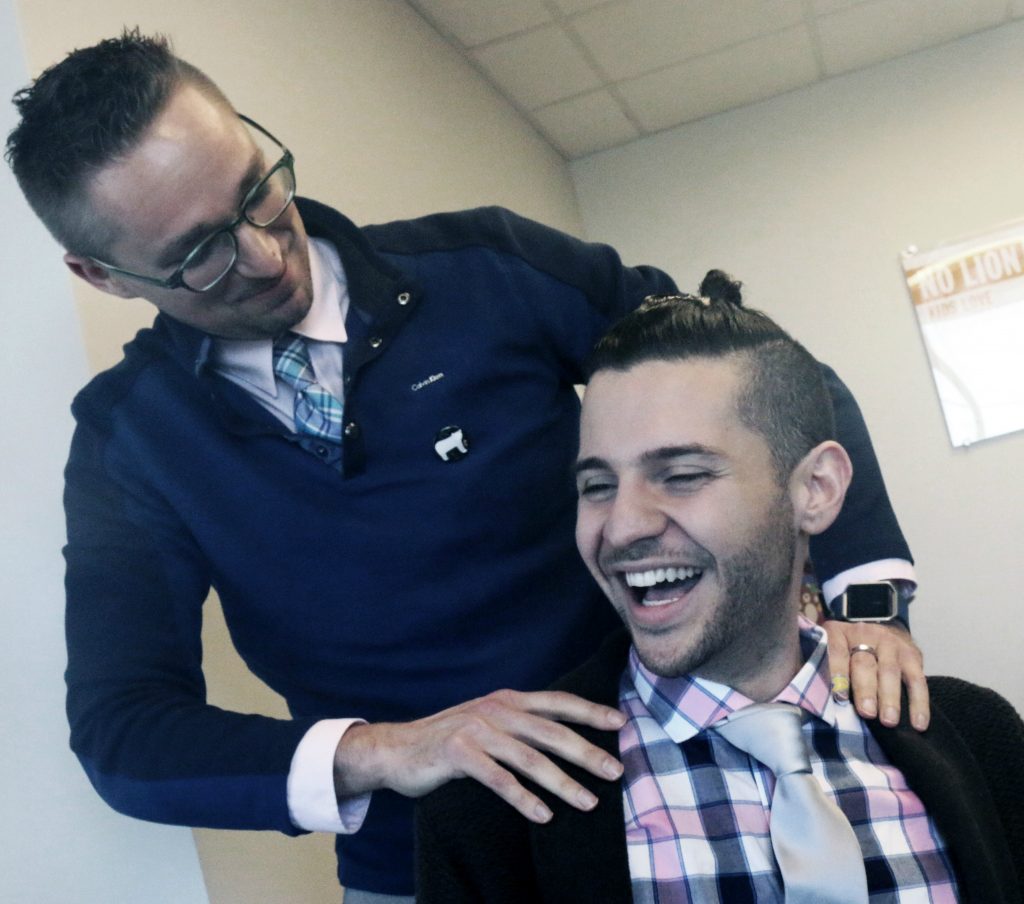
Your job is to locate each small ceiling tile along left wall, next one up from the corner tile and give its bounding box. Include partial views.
[471,26,601,110]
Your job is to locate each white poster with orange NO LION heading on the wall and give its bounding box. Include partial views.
[901,220,1024,446]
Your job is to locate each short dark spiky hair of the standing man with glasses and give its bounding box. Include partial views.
[4,29,230,257]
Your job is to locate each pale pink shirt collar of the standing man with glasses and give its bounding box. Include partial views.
[211,238,348,397]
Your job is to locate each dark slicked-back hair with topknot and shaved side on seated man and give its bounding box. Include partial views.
[588,270,836,484]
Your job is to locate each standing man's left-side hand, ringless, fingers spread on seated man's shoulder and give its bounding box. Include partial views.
[334,690,625,822]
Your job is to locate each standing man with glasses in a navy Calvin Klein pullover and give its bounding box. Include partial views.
[7,32,928,901]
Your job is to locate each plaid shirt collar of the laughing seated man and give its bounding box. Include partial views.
[627,615,836,743]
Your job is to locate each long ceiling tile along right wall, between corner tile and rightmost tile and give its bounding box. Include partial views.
[616,26,817,132]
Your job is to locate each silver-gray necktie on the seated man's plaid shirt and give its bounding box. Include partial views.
[714,703,867,904]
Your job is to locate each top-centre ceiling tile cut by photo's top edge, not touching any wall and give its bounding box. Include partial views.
[569,0,803,80]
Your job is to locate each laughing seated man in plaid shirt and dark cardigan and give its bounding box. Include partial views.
[417,278,1024,904]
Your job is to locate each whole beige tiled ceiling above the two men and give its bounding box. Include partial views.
[407,0,1024,160]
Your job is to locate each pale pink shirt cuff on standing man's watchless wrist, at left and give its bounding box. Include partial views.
[288,719,370,834]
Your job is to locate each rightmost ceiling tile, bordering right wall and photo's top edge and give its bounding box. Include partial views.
[817,0,1007,75]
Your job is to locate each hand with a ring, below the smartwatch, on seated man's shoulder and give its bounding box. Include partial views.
[825,620,931,731]
